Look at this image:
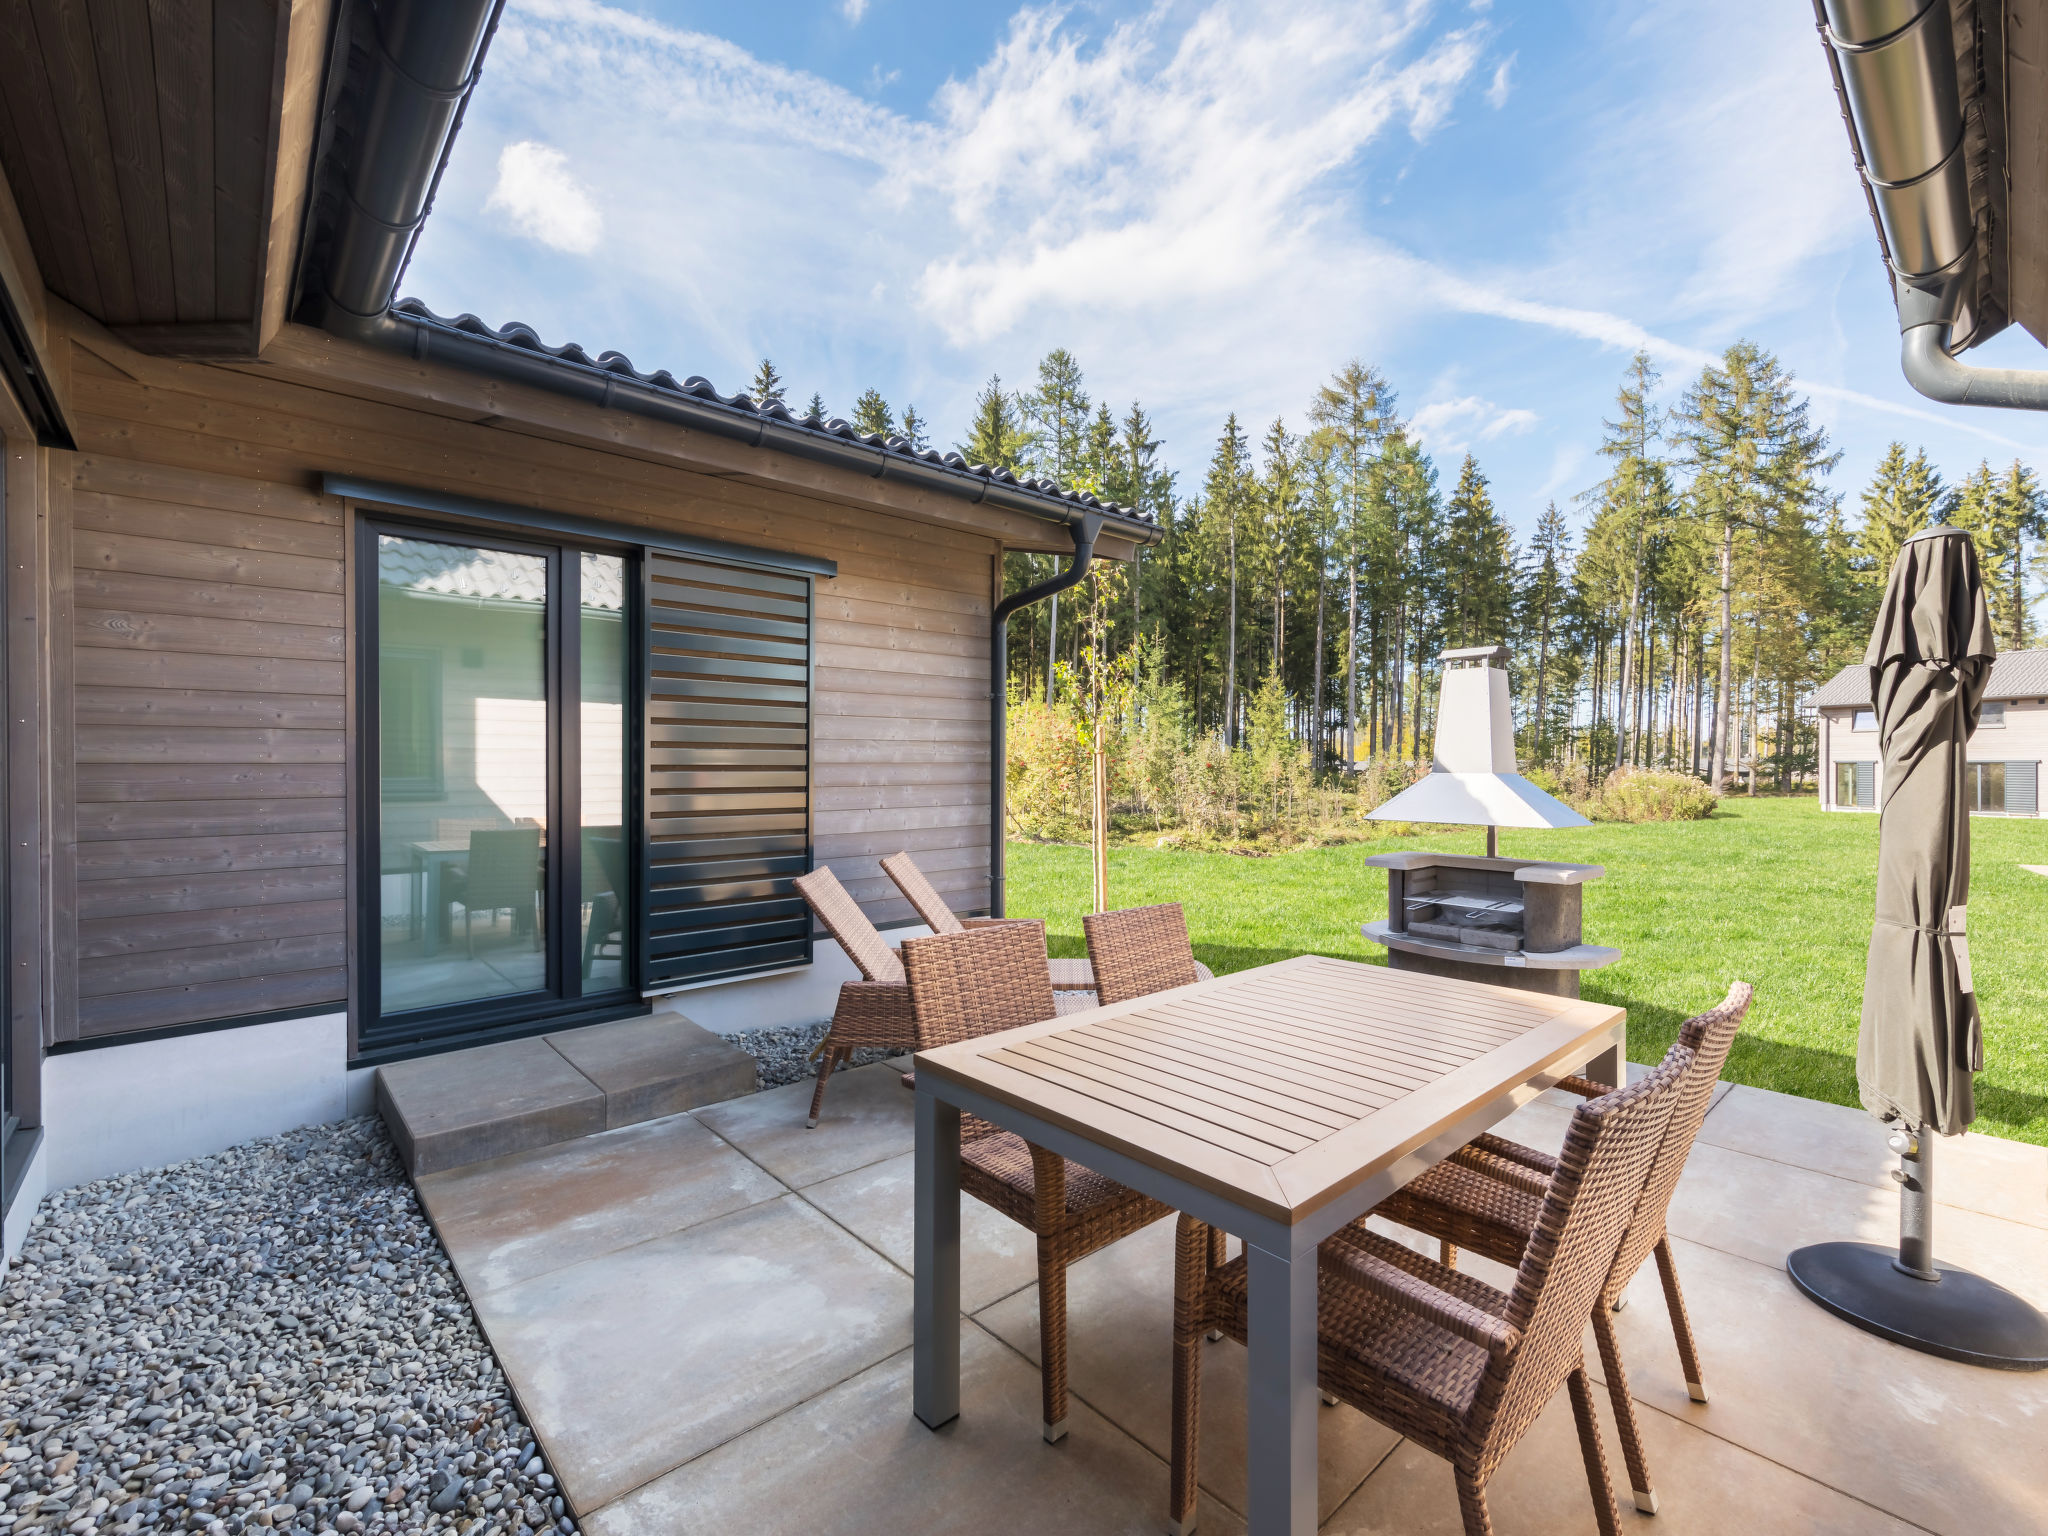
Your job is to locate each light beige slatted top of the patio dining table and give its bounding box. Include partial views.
[918,954,1624,1223]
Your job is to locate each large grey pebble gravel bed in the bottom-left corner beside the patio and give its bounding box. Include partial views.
[0,1118,575,1536]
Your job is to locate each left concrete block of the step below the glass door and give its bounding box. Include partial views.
[377,1036,604,1176]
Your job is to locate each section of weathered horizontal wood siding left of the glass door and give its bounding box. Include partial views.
[70,453,348,1038]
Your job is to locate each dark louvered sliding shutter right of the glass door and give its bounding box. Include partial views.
[641,549,811,987]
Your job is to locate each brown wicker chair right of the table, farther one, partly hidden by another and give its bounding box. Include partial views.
[1374,981,1751,1516]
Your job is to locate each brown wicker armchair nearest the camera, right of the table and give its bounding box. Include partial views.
[1171,1049,1692,1536]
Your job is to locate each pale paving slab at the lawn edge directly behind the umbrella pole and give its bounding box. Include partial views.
[1700,1085,2048,1227]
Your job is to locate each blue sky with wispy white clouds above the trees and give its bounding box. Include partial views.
[403,0,2048,544]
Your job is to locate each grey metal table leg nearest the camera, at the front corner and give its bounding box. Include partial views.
[1245,1243,1317,1536]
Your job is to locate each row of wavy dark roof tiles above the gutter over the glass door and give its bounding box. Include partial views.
[391,299,1159,543]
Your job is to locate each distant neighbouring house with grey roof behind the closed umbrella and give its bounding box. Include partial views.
[1812,647,2048,815]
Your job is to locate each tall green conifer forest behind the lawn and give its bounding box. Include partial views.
[756,342,2048,811]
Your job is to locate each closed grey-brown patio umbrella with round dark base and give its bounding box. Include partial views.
[1786,526,2048,1370]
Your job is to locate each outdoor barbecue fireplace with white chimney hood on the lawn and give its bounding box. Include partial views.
[1360,645,1622,997]
